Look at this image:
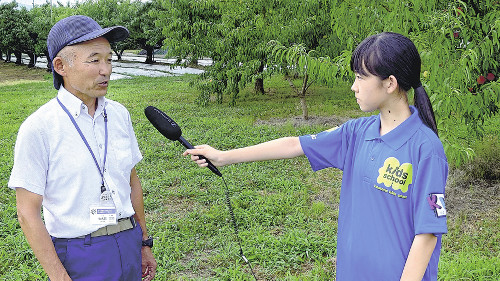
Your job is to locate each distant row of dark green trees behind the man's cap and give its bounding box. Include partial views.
[0,0,165,67]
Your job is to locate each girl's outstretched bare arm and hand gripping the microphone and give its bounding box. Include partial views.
[183,137,304,167]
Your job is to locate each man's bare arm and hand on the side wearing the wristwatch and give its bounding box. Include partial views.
[130,168,156,281]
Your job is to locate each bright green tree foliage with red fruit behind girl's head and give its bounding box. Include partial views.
[292,0,500,163]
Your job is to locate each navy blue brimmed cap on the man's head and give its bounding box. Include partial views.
[47,15,129,90]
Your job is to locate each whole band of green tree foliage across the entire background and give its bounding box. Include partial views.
[0,0,500,164]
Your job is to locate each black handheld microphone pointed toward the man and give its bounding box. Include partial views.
[144,106,222,177]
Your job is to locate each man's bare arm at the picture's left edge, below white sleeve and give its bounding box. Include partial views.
[16,188,71,281]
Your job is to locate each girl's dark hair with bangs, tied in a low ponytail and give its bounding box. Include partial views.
[351,32,438,135]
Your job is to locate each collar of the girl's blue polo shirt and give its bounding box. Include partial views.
[365,106,423,150]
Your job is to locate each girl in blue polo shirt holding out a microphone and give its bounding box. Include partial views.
[184,32,448,281]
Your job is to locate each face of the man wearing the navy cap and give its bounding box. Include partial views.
[61,37,112,102]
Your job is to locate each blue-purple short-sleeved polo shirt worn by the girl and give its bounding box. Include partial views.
[300,106,448,281]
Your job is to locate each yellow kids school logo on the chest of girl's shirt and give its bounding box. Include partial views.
[377,157,413,193]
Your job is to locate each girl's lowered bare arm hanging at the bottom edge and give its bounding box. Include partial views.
[401,233,437,281]
